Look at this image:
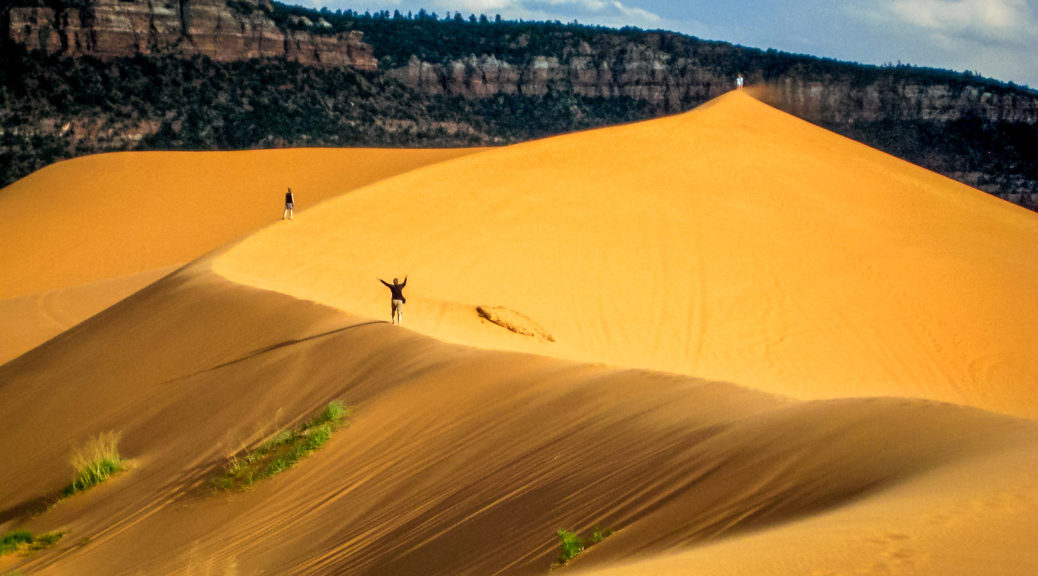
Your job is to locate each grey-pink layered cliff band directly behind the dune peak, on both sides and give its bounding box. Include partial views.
[387,42,1038,124]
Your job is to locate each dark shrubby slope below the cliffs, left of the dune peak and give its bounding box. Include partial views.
[0,47,649,185]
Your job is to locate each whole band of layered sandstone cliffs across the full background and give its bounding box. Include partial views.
[6,0,1038,125]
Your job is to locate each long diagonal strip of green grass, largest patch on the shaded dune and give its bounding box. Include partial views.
[213,401,350,490]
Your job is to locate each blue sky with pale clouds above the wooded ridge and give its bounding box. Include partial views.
[292,0,1038,88]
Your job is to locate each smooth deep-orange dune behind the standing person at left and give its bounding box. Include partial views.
[0,148,473,300]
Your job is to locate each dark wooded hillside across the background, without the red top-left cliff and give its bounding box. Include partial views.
[0,0,1038,207]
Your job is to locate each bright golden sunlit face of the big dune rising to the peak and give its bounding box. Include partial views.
[216,92,1038,417]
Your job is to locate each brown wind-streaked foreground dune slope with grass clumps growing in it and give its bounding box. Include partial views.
[0,266,1038,576]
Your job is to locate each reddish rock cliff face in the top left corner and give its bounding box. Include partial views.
[4,0,377,70]
